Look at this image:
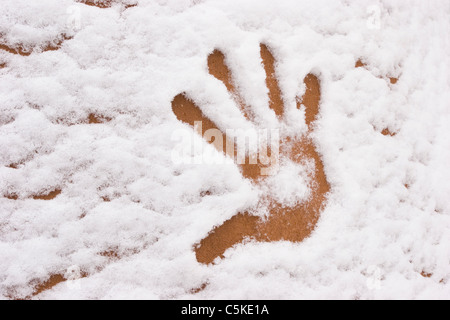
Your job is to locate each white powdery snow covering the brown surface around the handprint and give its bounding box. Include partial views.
[0,0,450,299]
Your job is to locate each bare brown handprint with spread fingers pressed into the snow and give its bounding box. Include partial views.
[172,44,330,264]
